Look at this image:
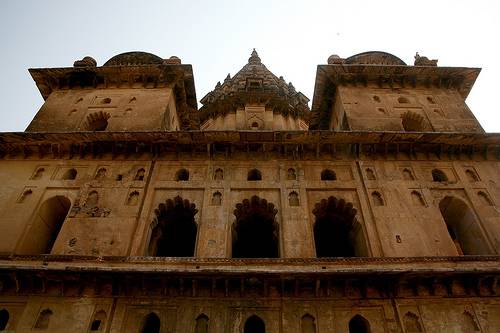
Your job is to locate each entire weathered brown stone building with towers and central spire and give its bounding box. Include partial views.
[0,50,500,333]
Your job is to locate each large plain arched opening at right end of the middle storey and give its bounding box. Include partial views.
[439,196,490,255]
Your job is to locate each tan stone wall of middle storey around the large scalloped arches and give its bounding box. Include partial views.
[0,155,500,258]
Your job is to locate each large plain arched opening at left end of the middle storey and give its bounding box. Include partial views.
[18,195,71,254]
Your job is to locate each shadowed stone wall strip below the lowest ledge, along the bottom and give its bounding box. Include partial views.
[0,296,500,333]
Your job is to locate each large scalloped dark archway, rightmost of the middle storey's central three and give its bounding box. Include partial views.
[313,196,365,257]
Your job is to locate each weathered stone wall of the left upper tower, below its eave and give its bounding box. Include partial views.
[26,88,179,132]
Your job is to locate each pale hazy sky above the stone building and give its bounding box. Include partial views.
[0,0,500,132]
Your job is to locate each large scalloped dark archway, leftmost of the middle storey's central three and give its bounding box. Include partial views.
[148,196,198,257]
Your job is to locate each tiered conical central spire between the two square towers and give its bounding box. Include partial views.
[200,49,309,130]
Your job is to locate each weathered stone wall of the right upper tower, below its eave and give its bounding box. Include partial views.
[330,85,483,133]
